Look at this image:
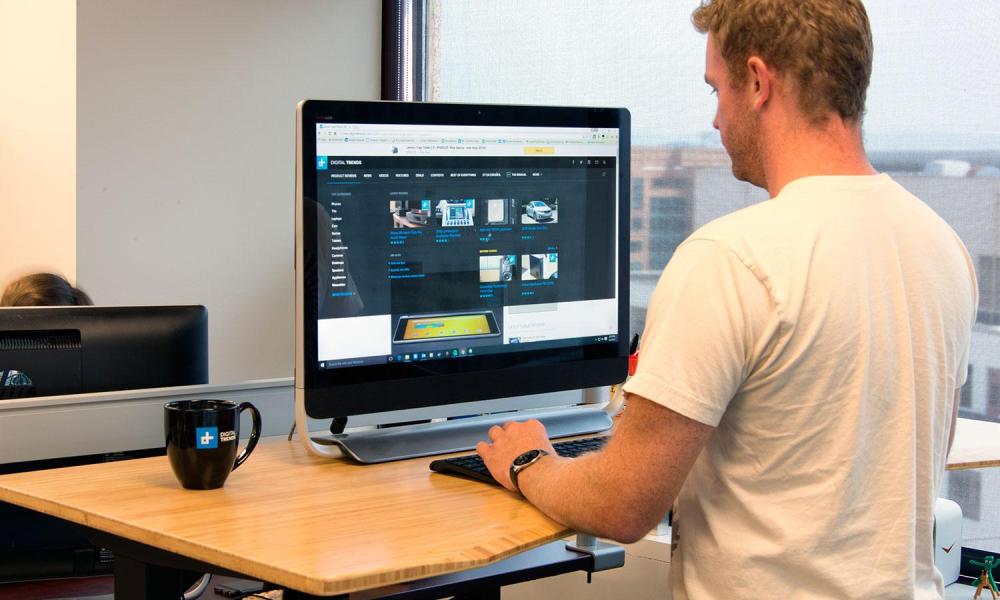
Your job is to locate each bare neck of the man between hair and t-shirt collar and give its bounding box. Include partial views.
[761,113,876,198]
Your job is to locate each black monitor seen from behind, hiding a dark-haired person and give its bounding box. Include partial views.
[0,306,208,398]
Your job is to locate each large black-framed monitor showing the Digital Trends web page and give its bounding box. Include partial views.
[296,101,629,458]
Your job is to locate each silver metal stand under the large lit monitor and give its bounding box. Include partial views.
[295,390,611,463]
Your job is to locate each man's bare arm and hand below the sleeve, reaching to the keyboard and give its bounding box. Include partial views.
[476,394,715,543]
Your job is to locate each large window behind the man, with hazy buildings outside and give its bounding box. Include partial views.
[426,0,1000,550]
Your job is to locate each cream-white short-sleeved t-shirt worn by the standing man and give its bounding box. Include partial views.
[625,175,977,600]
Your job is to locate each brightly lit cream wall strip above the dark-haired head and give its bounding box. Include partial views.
[0,0,76,291]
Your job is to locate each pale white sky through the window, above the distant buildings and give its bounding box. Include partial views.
[438,0,1000,151]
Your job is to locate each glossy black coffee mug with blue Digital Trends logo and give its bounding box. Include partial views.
[163,400,261,490]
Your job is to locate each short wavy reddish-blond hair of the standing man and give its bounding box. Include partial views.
[691,0,872,123]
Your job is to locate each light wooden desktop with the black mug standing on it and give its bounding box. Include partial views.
[0,438,570,595]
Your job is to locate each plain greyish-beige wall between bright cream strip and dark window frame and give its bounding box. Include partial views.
[77,0,381,383]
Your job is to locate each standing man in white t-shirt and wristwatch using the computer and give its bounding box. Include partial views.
[477,0,977,599]
